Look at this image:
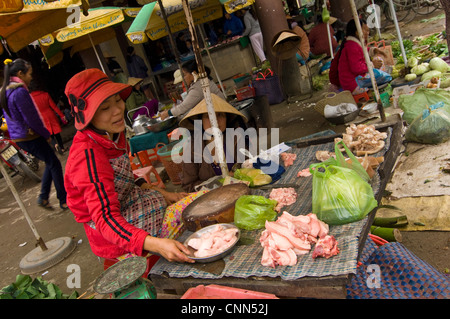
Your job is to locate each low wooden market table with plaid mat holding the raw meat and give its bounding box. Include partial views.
[149,122,402,298]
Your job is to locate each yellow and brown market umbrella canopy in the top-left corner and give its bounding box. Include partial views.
[0,0,89,54]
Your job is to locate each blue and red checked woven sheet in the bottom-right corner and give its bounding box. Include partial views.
[347,238,450,299]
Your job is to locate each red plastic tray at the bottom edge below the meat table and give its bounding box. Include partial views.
[181,285,279,299]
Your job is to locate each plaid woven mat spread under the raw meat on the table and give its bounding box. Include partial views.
[150,130,392,280]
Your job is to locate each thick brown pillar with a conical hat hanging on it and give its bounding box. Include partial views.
[255,0,301,96]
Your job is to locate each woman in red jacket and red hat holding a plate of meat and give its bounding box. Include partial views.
[65,69,193,262]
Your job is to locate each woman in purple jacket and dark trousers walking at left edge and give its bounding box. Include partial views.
[0,59,68,209]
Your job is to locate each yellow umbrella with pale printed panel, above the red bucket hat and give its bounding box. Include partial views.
[39,7,141,72]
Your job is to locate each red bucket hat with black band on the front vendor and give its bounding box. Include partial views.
[64,69,132,131]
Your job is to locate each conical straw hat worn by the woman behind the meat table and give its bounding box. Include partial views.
[180,93,247,129]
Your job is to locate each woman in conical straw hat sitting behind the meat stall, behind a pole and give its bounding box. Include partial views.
[180,94,248,192]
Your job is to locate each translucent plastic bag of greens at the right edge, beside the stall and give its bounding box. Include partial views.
[405,102,450,144]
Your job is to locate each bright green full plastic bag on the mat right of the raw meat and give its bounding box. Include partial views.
[310,163,378,225]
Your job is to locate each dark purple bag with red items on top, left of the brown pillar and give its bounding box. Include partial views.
[252,69,284,105]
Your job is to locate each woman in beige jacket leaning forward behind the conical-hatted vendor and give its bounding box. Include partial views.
[161,60,225,120]
